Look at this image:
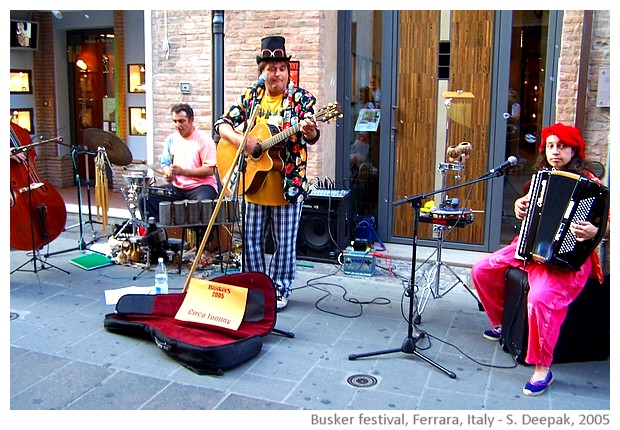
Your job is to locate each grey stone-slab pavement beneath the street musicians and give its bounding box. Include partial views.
[8,212,611,428]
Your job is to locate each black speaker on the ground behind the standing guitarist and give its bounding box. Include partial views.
[297,190,350,263]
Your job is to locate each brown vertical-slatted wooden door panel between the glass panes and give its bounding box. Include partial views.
[393,11,494,243]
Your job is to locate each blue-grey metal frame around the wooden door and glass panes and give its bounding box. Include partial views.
[336,10,563,252]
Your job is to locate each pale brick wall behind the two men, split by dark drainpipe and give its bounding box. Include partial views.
[151,10,324,176]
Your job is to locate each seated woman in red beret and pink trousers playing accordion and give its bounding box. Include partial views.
[471,123,609,396]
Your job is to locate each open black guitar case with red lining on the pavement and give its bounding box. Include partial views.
[104,272,294,375]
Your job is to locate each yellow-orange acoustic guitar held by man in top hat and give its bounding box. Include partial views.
[215,102,342,197]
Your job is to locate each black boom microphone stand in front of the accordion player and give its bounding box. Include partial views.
[349,169,504,379]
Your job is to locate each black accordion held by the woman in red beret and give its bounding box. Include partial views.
[515,170,609,270]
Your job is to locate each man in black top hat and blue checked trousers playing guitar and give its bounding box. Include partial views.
[214,36,320,310]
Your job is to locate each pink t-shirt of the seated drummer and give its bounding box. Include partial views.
[161,129,217,191]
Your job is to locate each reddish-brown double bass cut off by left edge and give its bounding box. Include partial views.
[10,122,67,251]
